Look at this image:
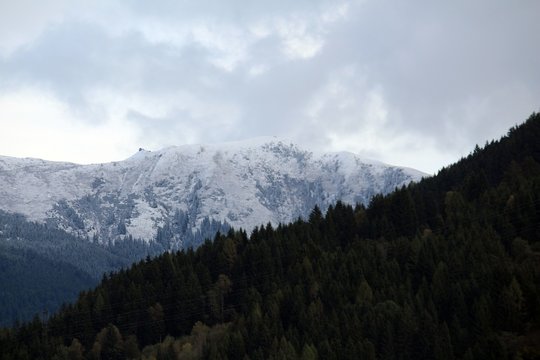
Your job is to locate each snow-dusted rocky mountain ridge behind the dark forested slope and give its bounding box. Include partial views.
[0,138,425,247]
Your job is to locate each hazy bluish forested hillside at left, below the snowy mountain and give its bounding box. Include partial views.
[0,210,163,326]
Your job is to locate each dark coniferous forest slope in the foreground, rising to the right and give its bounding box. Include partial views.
[0,114,540,359]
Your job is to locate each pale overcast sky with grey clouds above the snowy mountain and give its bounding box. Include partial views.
[0,0,540,173]
